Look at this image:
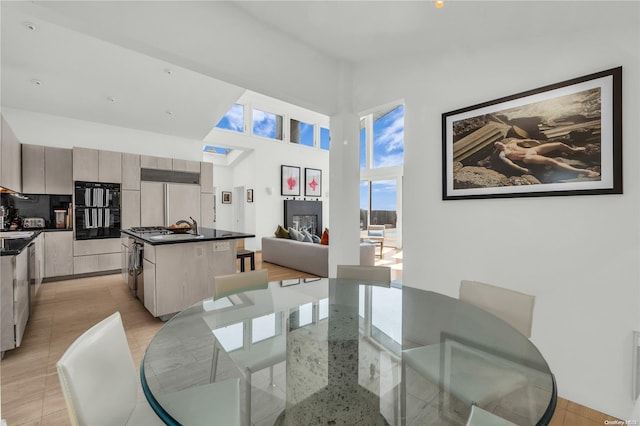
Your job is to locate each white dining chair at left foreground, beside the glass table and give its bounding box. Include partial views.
[56,312,164,426]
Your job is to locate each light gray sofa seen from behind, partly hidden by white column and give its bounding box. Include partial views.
[262,237,375,277]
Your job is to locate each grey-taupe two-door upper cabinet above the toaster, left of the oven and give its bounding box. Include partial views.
[22,144,73,195]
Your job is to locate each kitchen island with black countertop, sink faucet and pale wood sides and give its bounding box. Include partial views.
[121,227,255,320]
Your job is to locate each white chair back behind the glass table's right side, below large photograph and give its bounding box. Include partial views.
[459,280,535,337]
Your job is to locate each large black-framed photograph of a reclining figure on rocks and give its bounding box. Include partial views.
[442,67,622,200]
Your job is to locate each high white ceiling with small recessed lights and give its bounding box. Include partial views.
[0,0,620,139]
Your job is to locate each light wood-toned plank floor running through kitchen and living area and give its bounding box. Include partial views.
[0,248,614,426]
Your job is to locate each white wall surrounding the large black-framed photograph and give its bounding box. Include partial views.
[354,2,640,419]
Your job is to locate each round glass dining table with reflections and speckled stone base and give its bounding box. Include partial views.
[140,278,556,426]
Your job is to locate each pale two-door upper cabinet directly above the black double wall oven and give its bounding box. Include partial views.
[73,147,122,183]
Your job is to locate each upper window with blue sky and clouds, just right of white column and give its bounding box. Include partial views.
[373,105,404,168]
